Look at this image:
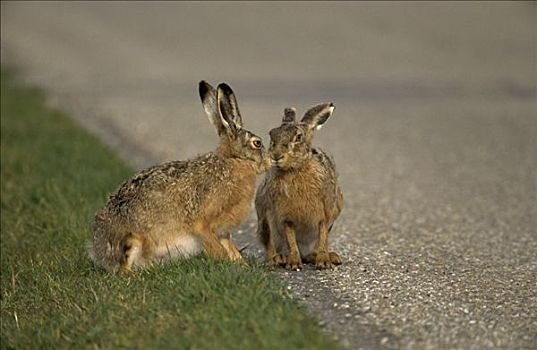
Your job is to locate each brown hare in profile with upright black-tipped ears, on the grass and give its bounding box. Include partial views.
[91,81,267,272]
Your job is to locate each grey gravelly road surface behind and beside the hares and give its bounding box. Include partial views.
[1,2,537,349]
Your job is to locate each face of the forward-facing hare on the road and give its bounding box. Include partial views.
[268,123,311,169]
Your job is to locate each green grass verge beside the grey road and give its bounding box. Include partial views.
[1,70,338,349]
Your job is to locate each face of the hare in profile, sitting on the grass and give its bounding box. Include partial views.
[228,129,266,173]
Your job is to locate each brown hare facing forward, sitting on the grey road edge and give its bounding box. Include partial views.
[255,103,343,270]
